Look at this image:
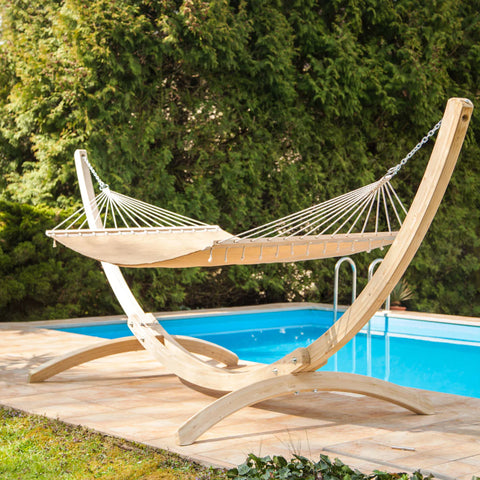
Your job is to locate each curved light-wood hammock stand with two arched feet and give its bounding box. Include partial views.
[30,98,473,445]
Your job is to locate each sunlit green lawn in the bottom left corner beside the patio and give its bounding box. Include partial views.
[0,407,226,480]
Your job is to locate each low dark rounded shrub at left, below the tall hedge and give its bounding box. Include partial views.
[0,201,119,321]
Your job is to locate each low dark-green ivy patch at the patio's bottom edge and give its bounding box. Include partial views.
[227,454,433,480]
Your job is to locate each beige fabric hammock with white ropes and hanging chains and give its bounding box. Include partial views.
[46,122,441,268]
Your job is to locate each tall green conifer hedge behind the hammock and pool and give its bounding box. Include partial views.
[0,0,480,315]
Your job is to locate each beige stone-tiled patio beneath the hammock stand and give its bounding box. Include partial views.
[0,316,480,480]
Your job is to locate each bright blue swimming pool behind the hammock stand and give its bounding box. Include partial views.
[56,308,480,398]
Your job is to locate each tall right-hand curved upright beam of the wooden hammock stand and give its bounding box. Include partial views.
[298,98,473,371]
